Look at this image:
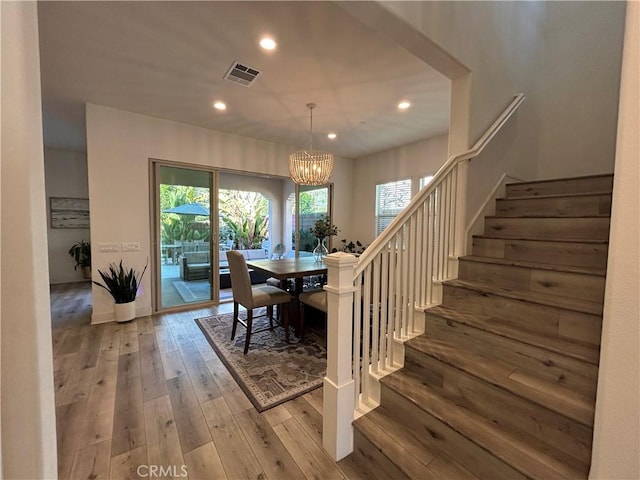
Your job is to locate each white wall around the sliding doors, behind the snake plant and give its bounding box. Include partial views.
[86,105,352,322]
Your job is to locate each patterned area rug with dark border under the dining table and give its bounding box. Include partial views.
[196,310,327,412]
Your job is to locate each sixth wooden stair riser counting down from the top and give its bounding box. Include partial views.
[442,284,602,345]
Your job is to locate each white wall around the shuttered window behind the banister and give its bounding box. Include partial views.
[348,135,448,244]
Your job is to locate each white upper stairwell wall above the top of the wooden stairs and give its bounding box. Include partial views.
[345,1,624,228]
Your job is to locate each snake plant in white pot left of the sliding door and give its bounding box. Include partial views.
[93,260,148,322]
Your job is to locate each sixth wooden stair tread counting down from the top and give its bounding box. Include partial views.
[443,279,603,317]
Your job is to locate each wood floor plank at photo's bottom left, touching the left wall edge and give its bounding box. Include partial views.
[56,399,87,479]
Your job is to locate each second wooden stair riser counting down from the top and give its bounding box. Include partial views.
[496,194,611,217]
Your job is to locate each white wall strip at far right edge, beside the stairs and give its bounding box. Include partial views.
[590,2,640,480]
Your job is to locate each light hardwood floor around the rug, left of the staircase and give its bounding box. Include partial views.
[51,283,362,480]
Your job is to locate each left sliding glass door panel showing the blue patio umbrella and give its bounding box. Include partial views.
[153,162,219,311]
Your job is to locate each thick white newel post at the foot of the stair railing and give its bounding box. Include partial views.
[322,252,358,461]
